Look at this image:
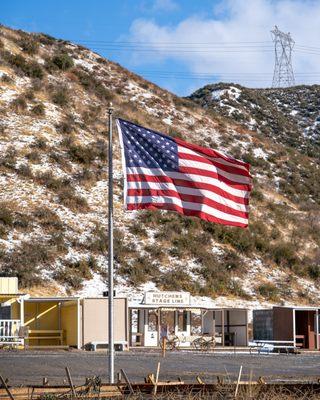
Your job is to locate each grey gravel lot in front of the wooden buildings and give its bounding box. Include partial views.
[0,350,320,385]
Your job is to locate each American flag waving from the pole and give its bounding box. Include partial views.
[117,119,252,228]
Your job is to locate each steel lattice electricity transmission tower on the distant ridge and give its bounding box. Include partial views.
[271,26,295,87]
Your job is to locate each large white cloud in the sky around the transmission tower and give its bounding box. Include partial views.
[130,0,320,87]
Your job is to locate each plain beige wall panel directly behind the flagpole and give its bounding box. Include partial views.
[81,298,128,346]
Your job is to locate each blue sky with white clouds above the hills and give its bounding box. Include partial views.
[0,0,320,95]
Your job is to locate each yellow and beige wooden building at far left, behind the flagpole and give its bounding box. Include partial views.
[0,277,128,349]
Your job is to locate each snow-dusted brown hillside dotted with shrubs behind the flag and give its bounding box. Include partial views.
[0,27,320,303]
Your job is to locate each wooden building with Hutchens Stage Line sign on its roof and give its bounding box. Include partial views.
[129,292,248,347]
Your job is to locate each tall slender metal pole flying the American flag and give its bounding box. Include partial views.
[108,103,114,383]
